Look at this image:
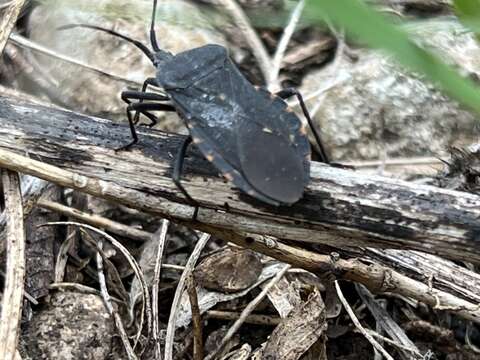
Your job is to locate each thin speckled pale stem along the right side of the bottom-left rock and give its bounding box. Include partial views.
[95,240,138,360]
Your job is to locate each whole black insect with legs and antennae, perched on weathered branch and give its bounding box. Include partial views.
[62,0,328,215]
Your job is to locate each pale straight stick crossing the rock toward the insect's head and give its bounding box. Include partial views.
[10,33,142,87]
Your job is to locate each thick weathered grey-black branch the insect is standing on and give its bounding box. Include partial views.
[0,97,480,263]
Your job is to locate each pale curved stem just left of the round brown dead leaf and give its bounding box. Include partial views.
[164,233,210,360]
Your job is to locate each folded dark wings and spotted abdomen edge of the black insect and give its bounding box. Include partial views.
[169,49,310,205]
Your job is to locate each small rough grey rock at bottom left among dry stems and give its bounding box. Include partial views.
[23,292,115,360]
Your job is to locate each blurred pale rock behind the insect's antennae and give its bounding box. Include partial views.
[29,0,224,130]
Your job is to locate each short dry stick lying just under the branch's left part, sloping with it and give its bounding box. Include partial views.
[41,199,153,242]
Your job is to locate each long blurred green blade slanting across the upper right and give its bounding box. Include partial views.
[305,0,480,114]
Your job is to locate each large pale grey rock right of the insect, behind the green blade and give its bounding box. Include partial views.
[301,21,480,160]
